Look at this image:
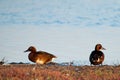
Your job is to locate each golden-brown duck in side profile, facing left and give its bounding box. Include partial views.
[24,46,57,64]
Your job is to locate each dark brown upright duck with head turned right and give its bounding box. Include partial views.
[89,44,106,65]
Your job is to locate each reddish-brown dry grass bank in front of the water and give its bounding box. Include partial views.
[0,64,120,80]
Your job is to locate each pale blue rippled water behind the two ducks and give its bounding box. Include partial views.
[0,0,120,64]
